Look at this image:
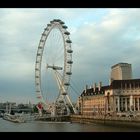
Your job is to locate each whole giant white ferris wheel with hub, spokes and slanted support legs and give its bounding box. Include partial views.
[35,19,76,113]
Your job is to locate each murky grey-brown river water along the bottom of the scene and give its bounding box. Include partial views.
[0,118,140,132]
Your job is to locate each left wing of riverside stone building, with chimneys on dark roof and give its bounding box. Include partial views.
[78,82,108,115]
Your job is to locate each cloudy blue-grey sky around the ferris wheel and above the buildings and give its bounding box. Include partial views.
[0,8,140,103]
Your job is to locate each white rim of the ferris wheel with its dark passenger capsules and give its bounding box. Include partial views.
[35,19,73,102]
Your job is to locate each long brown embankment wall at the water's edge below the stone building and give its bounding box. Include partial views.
[70,115,140,128]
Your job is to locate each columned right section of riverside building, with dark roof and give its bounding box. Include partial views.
[105,79,140,113]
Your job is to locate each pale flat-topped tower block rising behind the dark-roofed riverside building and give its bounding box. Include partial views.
[110,63,132,82]
